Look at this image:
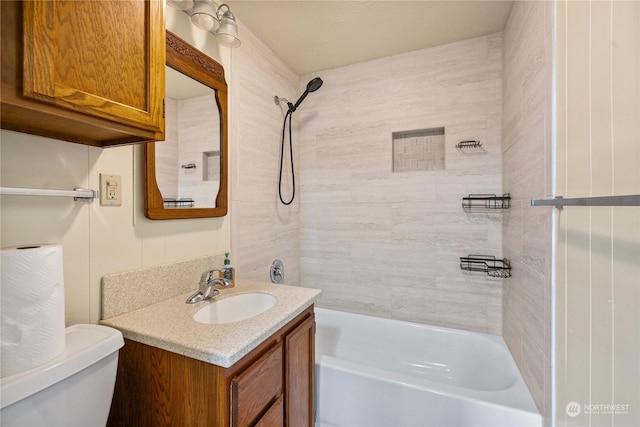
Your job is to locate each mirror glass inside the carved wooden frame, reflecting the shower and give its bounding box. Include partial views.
[155,67,220,208]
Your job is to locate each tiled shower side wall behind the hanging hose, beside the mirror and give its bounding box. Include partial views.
[229,25,300,285]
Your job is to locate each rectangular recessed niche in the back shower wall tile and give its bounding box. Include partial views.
[392,128,444,172]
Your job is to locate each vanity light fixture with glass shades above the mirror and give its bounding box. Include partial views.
[167,0,240,47]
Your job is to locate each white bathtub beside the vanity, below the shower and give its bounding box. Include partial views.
[316,308,542,427]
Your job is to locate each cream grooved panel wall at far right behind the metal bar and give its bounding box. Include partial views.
[554,1,640,426]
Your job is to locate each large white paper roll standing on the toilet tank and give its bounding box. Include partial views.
[0,245,65,377]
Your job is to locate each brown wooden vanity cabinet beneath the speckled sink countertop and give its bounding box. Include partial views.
[107,306,315,427]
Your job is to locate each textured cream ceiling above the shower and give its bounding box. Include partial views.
[227,0,513,74]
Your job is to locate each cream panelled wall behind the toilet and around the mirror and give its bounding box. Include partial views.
[0,8,233,325]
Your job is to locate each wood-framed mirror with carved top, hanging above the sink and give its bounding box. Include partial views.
[144,31,228,220]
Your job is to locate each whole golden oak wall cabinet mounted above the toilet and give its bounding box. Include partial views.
[0,0,166,147]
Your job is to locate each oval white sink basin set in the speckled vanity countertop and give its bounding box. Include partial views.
[193,293,277,324]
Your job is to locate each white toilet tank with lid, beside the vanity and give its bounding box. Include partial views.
[0,325,124,427]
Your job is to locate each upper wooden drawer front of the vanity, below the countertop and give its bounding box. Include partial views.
[231,342,283,427]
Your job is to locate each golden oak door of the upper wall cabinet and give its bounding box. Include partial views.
[23,0,166,133]
